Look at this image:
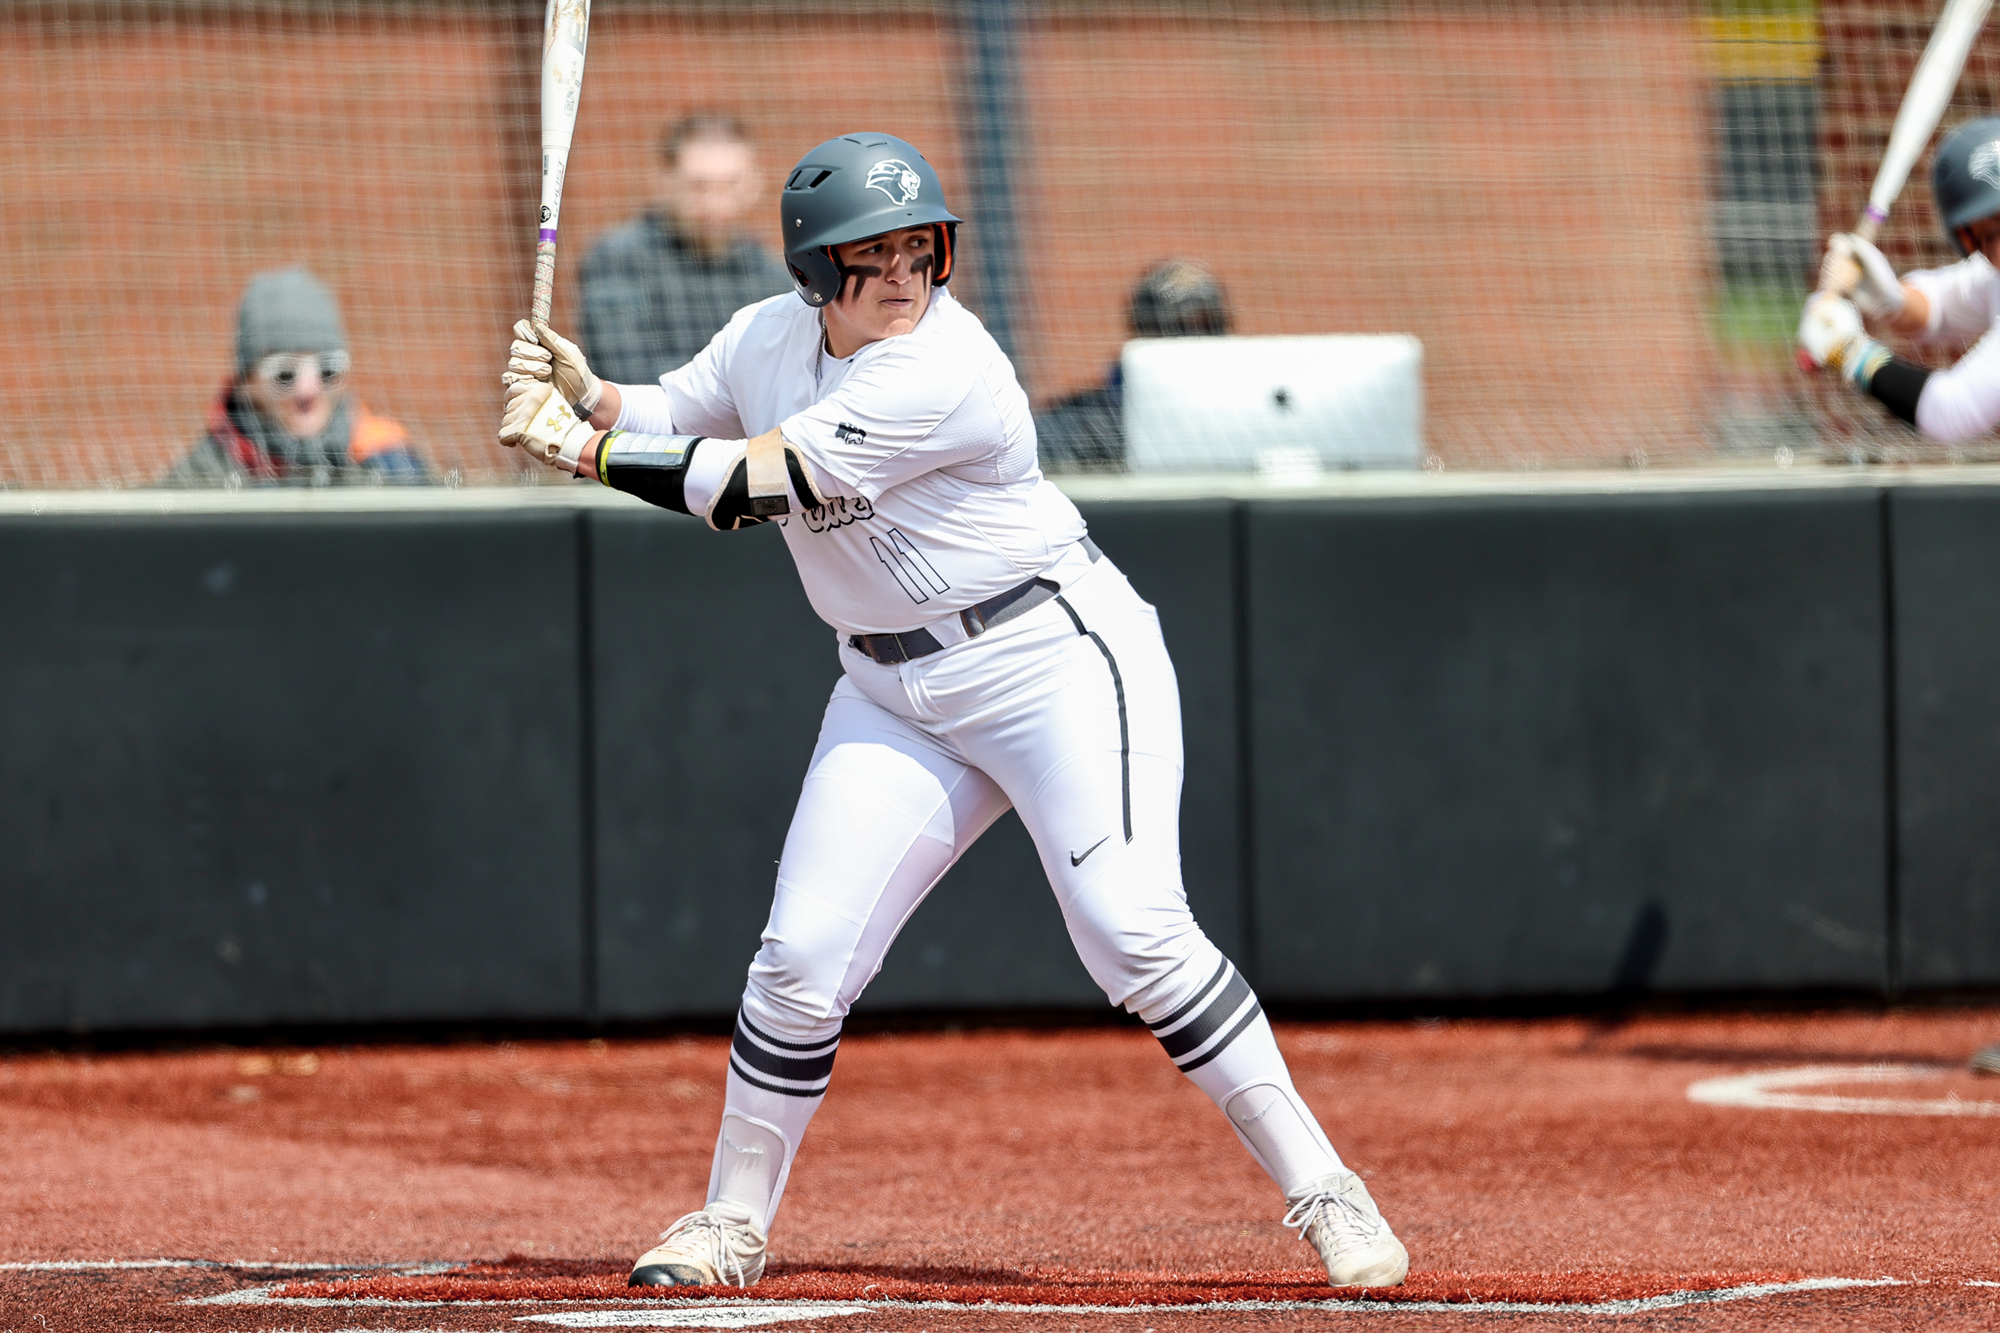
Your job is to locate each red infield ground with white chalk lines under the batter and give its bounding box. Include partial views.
[0,1009,2000,1333]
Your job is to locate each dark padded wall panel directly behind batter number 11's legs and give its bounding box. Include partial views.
[590,502,1238,1019]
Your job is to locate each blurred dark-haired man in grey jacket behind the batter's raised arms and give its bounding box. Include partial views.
[578,112,792,384]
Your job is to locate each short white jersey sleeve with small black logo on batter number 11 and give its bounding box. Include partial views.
[780,338,984,500]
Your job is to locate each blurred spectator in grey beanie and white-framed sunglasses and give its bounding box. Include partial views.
[160,268,432,486]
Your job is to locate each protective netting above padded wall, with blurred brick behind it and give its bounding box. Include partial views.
[0,0,2000,486]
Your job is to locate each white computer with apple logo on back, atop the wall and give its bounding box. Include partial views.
[1122,334,1424,480]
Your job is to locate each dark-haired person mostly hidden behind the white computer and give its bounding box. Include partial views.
[1034,260,1230,472]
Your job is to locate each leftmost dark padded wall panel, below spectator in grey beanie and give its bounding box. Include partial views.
[0,512,582,1031]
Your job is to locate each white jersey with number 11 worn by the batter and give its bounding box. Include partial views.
[618,290,1084,634]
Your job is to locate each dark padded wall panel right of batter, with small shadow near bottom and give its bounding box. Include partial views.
[1248,492,1886,999]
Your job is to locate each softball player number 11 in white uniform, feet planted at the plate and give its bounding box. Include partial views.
[500,134,1410,1285]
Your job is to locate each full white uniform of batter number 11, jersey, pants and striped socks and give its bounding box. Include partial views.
[618,288,1342,1227]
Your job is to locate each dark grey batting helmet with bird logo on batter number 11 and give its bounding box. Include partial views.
[778,134,960,306]
